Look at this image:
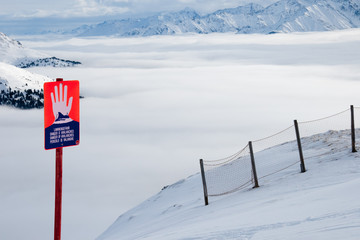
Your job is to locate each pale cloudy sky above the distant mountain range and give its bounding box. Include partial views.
[0,0,276,18]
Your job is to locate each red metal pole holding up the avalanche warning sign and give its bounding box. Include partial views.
[54,78,63,240]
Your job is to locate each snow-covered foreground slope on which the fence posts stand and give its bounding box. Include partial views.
[97,129,360,240]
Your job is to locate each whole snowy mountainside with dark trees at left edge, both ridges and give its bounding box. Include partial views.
[0,32,81,109]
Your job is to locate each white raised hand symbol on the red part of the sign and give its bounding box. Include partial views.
[51,83,73,121]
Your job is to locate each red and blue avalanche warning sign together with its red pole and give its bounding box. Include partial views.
[44,78,80,240]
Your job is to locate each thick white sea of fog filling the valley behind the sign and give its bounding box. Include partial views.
[0,29,360,240]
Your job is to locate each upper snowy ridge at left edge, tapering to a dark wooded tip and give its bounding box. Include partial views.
[0,32,81,68]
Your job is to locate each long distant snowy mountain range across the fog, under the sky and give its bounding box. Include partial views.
[70,0,360,37]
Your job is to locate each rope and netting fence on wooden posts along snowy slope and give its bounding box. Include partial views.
[200,106,360,205]
